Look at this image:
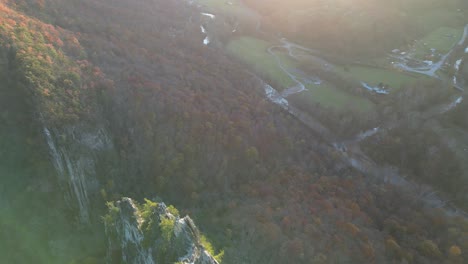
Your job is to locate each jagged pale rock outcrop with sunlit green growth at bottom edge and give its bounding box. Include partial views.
[104,198,218,264]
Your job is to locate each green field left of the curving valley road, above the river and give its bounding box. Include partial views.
[226,37,296,88]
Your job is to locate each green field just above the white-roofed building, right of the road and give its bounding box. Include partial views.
[336,66,420,92]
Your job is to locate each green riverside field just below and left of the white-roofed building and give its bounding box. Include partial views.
[289,83,375,112]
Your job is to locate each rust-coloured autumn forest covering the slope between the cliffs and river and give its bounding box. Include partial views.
[0,0,468,263]
